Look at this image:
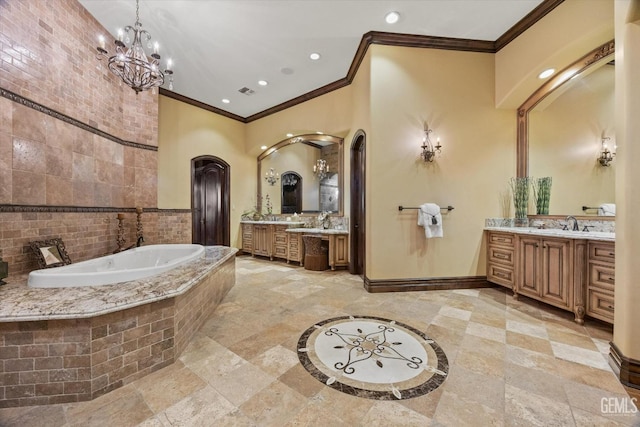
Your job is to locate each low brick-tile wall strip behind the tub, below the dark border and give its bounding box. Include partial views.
[0,210,191,277]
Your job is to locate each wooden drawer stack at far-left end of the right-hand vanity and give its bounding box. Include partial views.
[487,231,515,290]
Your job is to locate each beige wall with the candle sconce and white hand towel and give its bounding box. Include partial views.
[367,45,515,280]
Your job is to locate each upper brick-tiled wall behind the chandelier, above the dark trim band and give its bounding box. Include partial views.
[0,0,158,146]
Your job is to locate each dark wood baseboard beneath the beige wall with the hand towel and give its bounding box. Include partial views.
[364,276,495,293]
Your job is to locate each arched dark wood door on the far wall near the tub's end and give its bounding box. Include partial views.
[192,156,231,246]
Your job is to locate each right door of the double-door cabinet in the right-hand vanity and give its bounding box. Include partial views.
[538,239,573,307]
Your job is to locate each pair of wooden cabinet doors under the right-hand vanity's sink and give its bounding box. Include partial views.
[516,236,573,311]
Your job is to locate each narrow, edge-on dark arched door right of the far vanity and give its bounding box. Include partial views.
[349,130,365,275]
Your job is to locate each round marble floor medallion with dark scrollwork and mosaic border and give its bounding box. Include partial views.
[298,316,449,400]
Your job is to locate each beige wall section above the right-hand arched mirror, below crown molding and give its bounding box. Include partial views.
[495,0,614,109]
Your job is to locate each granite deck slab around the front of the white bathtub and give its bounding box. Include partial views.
[0,246,238,322]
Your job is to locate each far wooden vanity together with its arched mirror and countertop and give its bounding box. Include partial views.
[240,133,349,270]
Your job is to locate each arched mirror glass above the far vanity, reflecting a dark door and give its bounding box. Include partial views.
[258,134,343,215]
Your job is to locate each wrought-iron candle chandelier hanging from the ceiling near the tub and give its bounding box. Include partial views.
[96,0,173,95]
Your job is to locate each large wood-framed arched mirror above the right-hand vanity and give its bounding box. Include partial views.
[517,41,615,216]
